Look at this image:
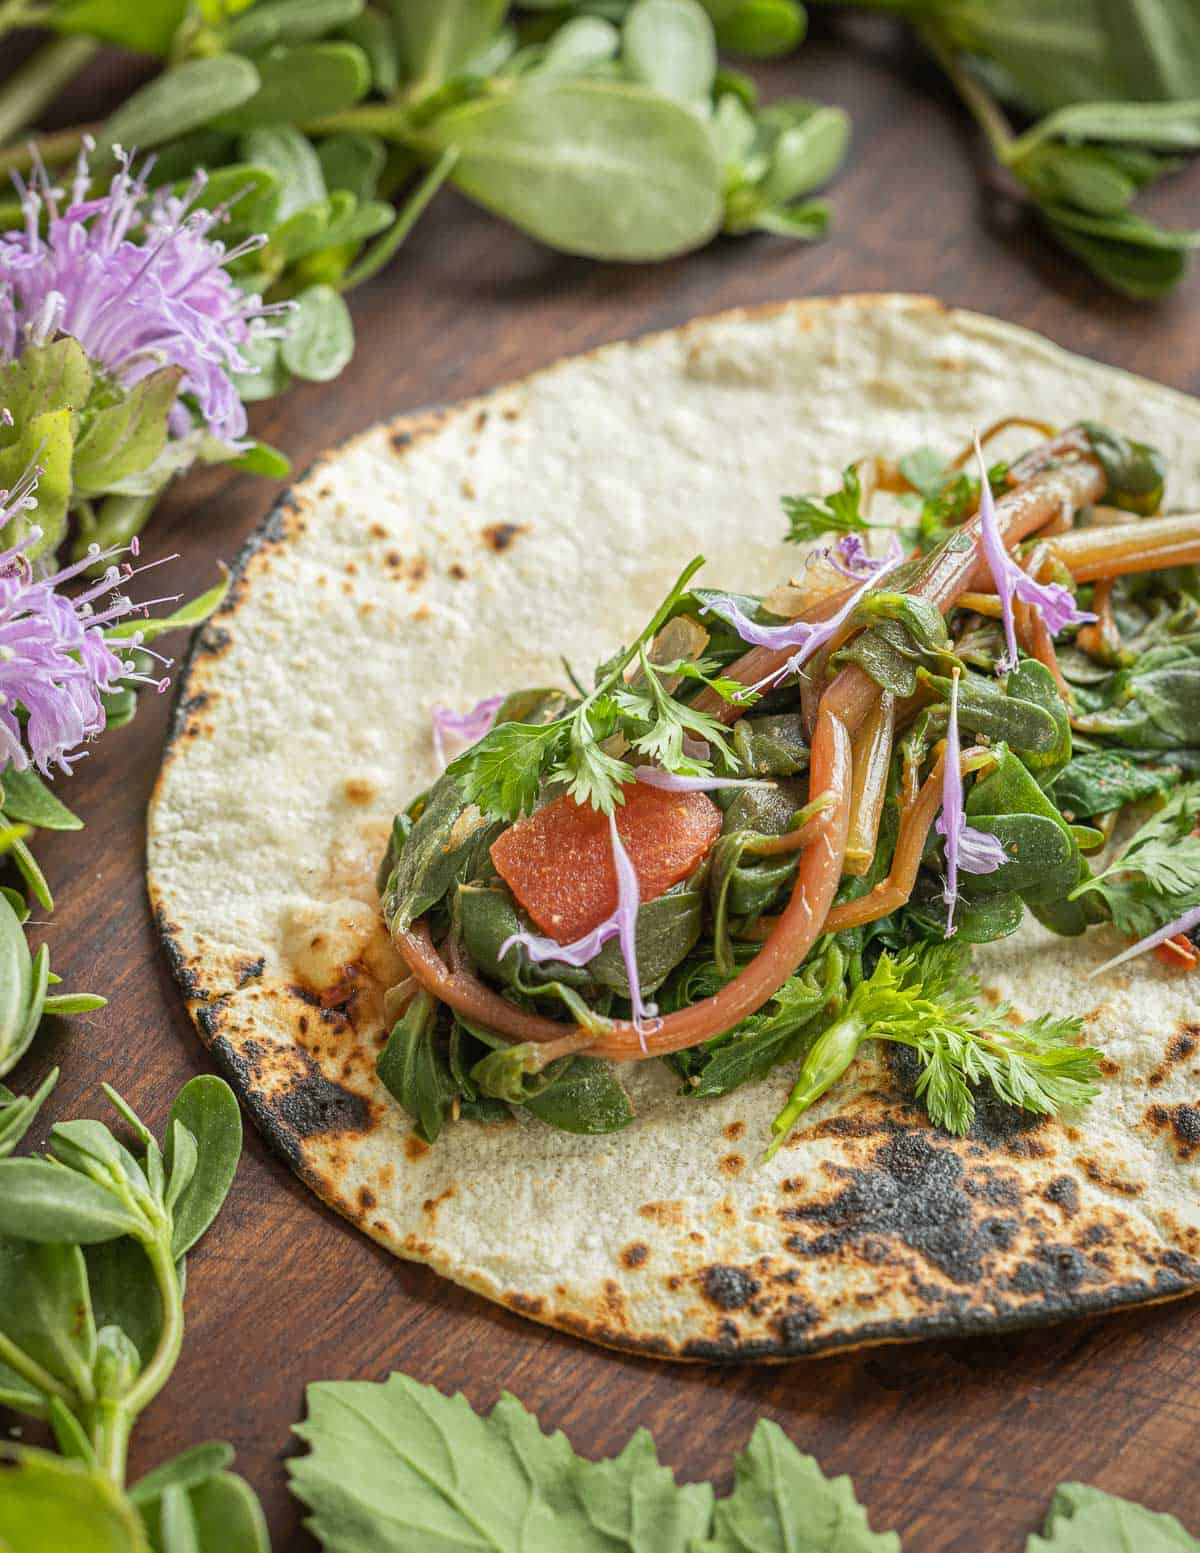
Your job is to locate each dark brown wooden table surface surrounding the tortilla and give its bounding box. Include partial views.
[14,19,1200,1553]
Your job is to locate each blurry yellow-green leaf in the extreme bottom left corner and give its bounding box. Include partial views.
[0,1443,151,1553]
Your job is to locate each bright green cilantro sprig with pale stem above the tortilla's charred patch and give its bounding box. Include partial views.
[767,943,1101,1159]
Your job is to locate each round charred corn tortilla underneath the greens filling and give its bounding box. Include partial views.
[149,297,1200,1359]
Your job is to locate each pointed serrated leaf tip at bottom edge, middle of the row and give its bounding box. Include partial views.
[694,1418,900,1553]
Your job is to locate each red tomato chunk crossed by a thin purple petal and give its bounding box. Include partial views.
[492,783,722,944]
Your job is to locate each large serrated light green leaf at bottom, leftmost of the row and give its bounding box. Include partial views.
[287,1374,711,1553]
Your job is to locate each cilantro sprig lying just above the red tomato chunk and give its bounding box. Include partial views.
[449,556,740,822]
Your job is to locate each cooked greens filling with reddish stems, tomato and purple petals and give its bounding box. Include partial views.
[379,422,1200,1152]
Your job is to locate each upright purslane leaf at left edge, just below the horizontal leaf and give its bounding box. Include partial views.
[0,1239,96,1396]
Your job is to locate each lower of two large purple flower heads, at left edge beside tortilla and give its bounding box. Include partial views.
[0,444,168,777]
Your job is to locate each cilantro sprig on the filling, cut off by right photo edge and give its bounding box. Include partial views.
[1071,781,1200,938]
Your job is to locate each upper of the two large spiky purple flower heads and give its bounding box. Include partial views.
[0,141,278,444]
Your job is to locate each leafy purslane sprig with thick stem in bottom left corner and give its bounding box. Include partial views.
[0,1075,270,1553]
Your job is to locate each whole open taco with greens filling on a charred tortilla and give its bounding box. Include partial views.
[149,297,1200,1359]
